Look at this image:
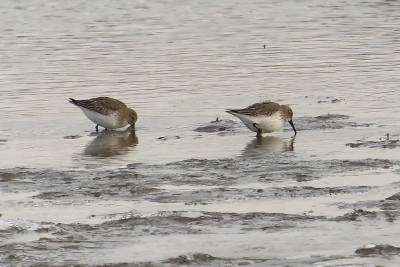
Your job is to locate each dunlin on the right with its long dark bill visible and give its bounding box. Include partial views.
[226,101,297,137]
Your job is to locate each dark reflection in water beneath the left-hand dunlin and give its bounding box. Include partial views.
[84,127,139,158]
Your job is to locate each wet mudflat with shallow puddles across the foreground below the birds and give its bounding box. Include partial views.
[1,158,399,266]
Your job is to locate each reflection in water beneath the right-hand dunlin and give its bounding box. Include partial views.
[244,136,295,154]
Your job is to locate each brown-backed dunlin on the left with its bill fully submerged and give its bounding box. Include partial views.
[69,97,137,132]
